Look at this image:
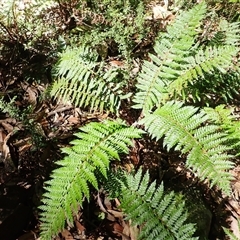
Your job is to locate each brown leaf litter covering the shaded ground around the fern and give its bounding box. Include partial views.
[0,0,240,240]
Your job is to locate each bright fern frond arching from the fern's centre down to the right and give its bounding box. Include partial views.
[140,102,233,194]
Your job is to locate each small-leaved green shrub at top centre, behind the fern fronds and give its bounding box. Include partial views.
[68,0,147,61]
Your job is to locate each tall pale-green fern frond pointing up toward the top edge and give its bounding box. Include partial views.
[133,3,206,111]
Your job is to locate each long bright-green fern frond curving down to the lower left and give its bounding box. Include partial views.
[40,121,143,240]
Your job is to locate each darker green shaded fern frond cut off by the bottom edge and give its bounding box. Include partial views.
[120,169,198,240]
